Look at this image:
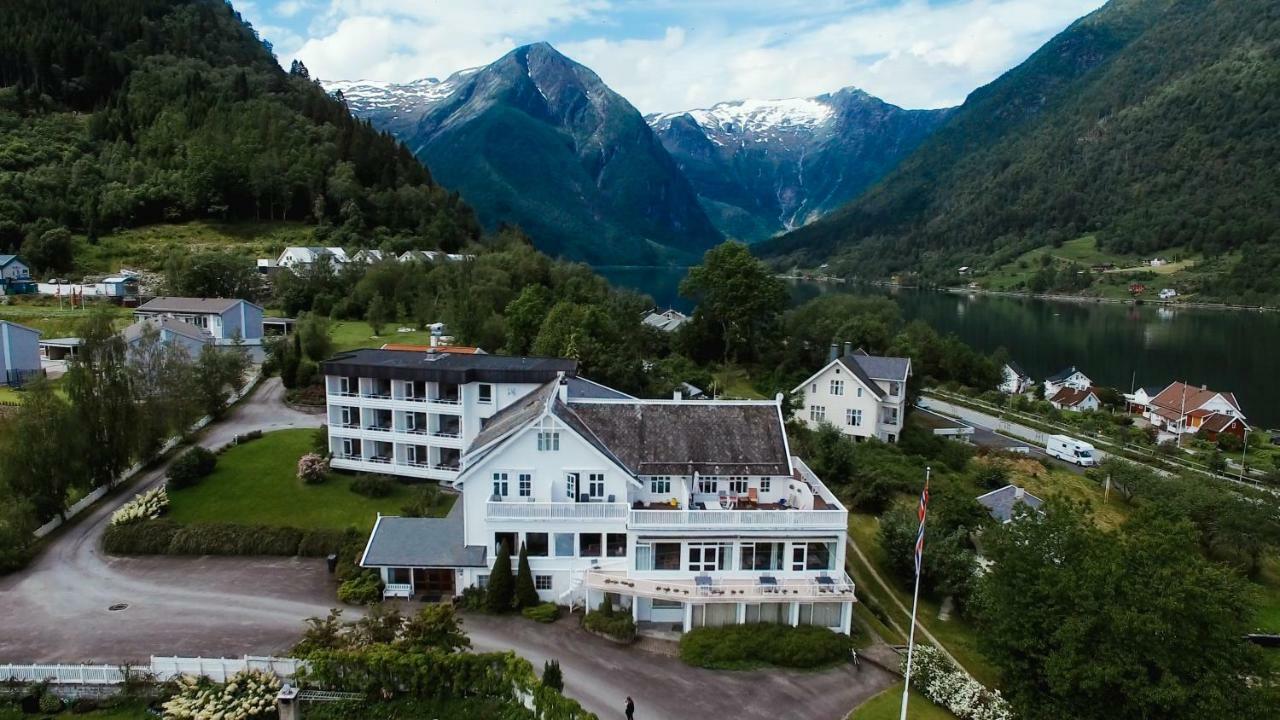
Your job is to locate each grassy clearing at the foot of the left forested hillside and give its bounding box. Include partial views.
[74,222,314,273]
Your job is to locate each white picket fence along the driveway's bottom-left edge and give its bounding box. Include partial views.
[0,655,300,685]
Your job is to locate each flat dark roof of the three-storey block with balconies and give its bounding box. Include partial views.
[320,348,577,384]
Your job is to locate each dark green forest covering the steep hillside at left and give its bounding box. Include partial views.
[0,0,479,270]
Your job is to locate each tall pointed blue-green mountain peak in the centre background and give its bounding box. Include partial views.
[330,44,721,265]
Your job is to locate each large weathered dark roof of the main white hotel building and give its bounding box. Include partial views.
[553,401,791,475]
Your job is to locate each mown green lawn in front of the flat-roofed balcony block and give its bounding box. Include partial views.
[169,429,454,532]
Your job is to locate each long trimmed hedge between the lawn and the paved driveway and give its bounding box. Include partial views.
[102,519,349,557]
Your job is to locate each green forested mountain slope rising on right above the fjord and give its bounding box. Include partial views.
[759,0,1280,296]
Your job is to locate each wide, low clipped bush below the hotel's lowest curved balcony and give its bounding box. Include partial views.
[680,623,852,670]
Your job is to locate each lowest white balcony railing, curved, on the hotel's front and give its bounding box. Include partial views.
[584,570,854,602]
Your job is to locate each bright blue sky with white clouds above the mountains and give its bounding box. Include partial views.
[232,0,1102,113]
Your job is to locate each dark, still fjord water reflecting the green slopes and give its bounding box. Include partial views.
[596,268,1280,427]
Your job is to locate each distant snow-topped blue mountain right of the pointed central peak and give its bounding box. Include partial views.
[645,87,950,242]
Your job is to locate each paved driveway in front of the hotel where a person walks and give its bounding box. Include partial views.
[465,615,897,720]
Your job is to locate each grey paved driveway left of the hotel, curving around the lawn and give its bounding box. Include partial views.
[0,378,334,662]
